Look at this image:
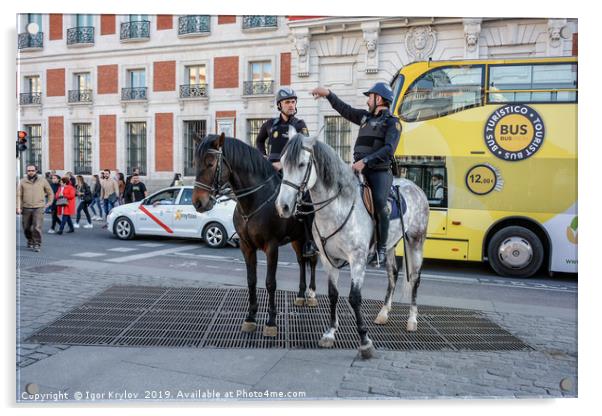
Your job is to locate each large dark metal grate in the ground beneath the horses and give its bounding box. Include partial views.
[26,286,532,351]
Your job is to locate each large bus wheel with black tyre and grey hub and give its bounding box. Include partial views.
[487,226,543,277]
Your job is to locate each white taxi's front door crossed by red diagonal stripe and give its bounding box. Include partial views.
[136,188,180,235]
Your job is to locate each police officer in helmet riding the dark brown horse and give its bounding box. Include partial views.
[255,87,317,257]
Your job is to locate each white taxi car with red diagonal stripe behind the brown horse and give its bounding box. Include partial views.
[107,186,238,248]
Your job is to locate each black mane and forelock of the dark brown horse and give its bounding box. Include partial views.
[195,134,274,177]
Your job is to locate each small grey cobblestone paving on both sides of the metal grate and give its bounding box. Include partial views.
[17,254,577,399]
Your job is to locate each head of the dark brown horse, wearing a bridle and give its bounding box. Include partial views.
[192,133,230,213]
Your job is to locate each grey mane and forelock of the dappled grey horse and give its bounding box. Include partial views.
[282,134,355,194]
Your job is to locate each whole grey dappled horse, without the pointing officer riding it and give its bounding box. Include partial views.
[276,130,429,358]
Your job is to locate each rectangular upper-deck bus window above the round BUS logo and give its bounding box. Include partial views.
[488,64,577,103]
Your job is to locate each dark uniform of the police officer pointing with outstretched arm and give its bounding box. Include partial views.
[326,90,401,264]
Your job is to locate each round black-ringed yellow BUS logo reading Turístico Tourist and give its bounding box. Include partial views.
[485,104,545,162]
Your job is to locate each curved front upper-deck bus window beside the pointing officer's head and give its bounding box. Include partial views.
[399,66,483,121]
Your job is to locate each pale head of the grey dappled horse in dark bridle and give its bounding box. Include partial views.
[276,127,318,218]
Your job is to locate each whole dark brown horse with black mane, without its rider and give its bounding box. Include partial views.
[192,133,318,337]
